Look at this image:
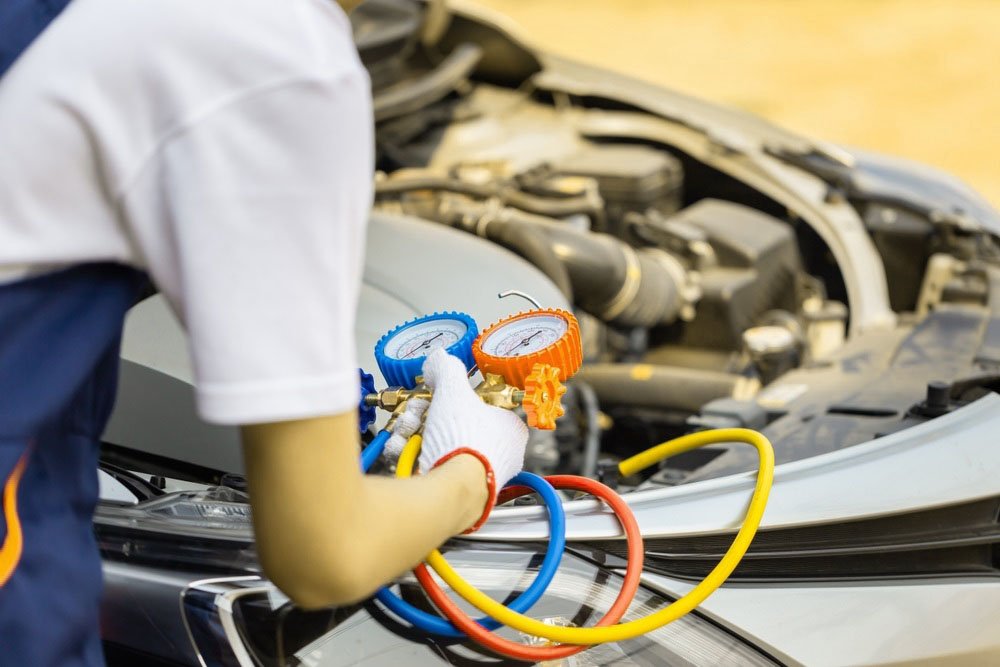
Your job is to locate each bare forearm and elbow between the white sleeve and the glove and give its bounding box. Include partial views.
[243,414,486,607]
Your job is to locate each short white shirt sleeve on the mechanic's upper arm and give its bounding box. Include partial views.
[122,68,373,424]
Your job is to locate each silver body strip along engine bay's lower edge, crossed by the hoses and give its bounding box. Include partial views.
[472,394,1000,541]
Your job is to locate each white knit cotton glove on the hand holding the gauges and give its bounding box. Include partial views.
[419,349,528,507]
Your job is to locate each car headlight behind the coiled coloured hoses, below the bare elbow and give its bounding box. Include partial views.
[182,544,775,667]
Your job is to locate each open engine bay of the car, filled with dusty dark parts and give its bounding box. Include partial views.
[360,3,1000,488]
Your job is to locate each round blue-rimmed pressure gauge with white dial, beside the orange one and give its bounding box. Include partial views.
[375,313,479,389]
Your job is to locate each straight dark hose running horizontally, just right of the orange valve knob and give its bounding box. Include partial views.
[574,364,760,412]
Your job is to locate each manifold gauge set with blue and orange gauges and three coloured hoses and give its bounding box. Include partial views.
[359,308,774,662]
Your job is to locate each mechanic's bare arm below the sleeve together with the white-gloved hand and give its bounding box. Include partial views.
[243,350,528,607]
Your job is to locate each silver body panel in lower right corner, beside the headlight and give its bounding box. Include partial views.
[643,575,1000,667]
